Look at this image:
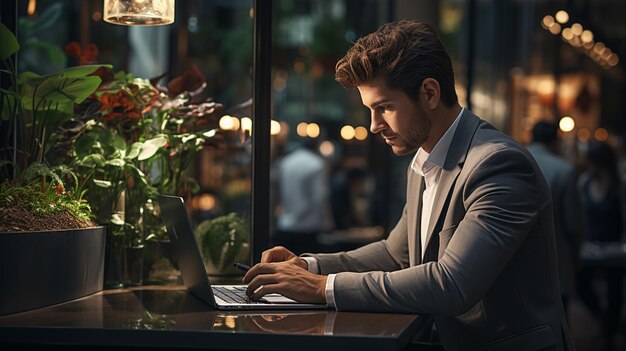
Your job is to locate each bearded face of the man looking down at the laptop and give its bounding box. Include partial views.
[357,77,431,155]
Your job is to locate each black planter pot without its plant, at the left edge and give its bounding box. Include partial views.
[0,227,105,315]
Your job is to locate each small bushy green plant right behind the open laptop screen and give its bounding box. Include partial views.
[195,213,250,276]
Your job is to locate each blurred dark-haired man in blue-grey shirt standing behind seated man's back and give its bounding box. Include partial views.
[527,121,584,311]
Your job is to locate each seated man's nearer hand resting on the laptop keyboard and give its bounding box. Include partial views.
[243,262,326,303]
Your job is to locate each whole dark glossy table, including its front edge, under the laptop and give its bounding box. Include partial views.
[0,286,424,350]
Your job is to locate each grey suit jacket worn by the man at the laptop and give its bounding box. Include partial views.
[304,110,573,350]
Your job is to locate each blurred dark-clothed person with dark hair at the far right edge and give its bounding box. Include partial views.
[578,142,626,349]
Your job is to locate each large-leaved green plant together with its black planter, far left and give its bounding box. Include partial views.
[0,23,105,315]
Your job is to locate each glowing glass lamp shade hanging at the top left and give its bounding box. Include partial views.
[104,0,175,26]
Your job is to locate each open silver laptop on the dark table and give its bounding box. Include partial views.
[157,195,328,310]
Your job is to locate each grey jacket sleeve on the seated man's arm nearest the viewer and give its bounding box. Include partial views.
[326,148,552,316]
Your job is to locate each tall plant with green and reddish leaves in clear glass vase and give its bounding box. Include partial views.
[53,59,227,287]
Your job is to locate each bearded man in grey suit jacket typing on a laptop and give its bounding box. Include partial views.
[243,21,571,350]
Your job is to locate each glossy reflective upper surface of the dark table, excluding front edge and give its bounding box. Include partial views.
[0,287,415,336]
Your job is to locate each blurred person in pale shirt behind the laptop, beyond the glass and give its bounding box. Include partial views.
[272,140,332,253]
